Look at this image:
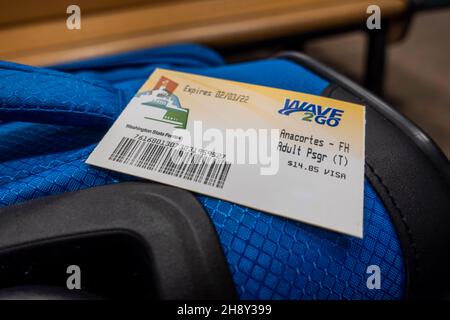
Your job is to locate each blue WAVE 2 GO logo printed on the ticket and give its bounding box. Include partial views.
[278,99,344,127]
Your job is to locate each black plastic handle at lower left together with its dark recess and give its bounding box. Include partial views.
[0,182,236,300]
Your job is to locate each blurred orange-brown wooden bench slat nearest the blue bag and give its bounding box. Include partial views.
[0,0,406,65]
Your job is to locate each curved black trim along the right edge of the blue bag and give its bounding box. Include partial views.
[277,52,450,299]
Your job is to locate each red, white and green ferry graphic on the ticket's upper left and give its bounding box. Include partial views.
[135,77,189,129]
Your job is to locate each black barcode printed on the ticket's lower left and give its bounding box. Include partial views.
[109,137,231,189]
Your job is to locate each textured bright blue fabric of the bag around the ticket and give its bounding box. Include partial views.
[0,45,405,299]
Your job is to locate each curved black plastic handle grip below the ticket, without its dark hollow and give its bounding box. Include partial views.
[0,182,235,299]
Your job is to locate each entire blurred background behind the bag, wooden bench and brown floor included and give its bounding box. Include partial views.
[0,0,450,157]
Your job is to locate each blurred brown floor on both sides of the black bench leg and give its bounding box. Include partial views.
[305,8,450,158]
